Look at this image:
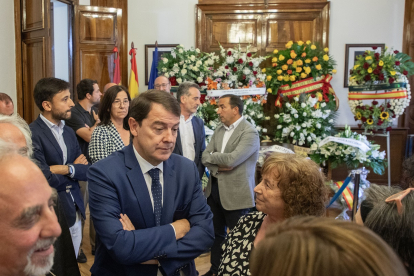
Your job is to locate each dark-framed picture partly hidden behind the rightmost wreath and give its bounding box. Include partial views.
[344,43,385,87]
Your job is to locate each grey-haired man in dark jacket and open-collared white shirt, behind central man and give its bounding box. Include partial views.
[173,82,206,179]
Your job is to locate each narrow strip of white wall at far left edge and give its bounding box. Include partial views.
[0,1,17,112]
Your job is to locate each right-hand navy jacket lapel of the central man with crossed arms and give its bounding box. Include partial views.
[161,159,177,225]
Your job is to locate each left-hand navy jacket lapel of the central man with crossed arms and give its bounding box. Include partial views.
[125,143,155,227]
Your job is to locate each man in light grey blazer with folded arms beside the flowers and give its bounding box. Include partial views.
[202,94,260,276]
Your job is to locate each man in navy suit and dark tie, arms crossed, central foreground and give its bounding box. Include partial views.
[88,91,213,276]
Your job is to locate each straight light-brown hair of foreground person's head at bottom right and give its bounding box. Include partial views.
[251,217,407,276]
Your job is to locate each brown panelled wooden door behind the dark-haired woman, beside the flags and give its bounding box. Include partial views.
[74,6,123,100]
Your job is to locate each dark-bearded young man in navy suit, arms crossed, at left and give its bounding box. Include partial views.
[30,78,89,256]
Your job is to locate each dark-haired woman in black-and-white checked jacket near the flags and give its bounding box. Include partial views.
[89,85,131,163]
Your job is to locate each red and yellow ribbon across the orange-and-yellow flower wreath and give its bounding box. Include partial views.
[275,75,335,107]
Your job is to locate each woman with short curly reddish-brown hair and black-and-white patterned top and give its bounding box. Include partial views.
[218,153,327,276]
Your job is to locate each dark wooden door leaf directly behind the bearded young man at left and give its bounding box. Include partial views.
[20,0,53,123]
